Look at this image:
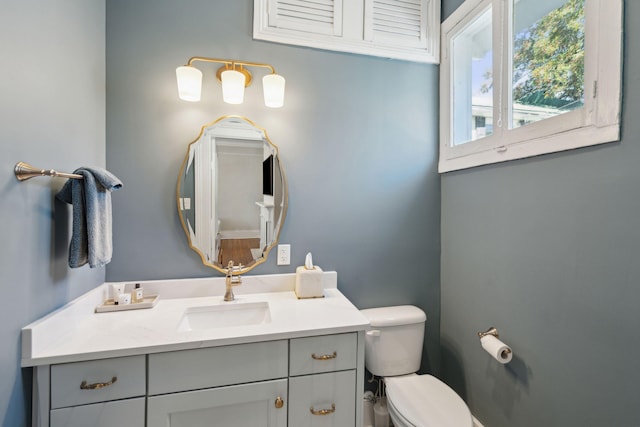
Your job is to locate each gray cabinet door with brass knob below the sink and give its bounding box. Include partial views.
[147,379,287,427]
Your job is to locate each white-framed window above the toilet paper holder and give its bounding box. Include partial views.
[439,0,623,172]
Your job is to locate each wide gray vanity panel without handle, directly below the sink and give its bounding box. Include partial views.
[149,340,288,396]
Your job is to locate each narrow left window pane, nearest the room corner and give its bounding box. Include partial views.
[452,8,493,146]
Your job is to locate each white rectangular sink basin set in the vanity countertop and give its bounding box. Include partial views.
[178,301,271,331]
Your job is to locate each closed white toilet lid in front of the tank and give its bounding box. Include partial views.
[385,375,473,427]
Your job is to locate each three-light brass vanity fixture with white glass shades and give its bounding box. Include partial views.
[176,56,285,108]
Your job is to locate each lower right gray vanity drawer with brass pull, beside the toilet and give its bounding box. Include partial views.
[289,370,356,427]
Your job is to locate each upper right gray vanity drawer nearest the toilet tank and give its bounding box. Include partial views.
[289,333,358,375]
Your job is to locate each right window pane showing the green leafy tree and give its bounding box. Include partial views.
[510,0,585,128]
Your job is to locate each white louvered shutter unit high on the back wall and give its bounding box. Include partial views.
[253,0,441,64]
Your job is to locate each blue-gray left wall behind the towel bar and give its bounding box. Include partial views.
[0,0,105,427]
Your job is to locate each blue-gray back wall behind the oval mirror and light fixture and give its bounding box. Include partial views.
[107,0,440,370]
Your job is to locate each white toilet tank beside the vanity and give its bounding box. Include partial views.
[361,305,427,377]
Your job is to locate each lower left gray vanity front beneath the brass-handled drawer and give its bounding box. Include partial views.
[50,397,144,427]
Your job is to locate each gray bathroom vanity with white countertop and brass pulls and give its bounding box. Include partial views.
[22,272,369,427]
